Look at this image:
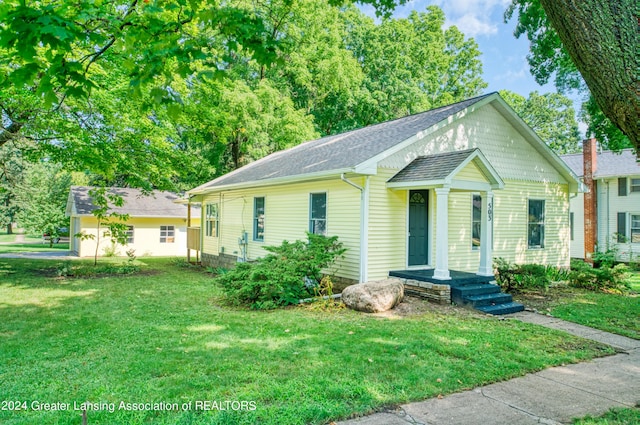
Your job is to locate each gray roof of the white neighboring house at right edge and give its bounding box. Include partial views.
[560,149,640,178]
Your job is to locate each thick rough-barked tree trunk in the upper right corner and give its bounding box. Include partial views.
[540,0,640,154]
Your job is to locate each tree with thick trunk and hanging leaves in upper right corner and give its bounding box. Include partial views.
[505,0,640,154]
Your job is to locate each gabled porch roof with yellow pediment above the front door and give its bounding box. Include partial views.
[387,148,504,191]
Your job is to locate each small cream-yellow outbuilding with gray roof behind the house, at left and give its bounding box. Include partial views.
[66,186,200,257]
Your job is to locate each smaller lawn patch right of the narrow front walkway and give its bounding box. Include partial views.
[515,273,640,339]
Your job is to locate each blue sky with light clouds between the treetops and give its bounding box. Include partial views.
[362,0,555,97]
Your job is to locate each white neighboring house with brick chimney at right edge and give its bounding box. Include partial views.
[561,139,640,262]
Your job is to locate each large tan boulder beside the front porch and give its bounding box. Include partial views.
[342,279,404,313]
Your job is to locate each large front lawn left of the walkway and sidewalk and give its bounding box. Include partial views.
[0,259,613,425]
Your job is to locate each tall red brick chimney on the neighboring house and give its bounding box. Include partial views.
[582,139,598,263]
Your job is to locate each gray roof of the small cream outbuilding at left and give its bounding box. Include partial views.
[70,186,199,218]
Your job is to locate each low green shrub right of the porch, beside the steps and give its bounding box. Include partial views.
[493,258,551,292]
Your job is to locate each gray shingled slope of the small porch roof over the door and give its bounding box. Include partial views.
[389,149,477,183]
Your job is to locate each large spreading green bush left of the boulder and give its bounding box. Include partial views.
[214,233,346,309]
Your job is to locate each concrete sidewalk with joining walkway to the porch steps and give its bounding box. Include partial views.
[338,311,640,425]
